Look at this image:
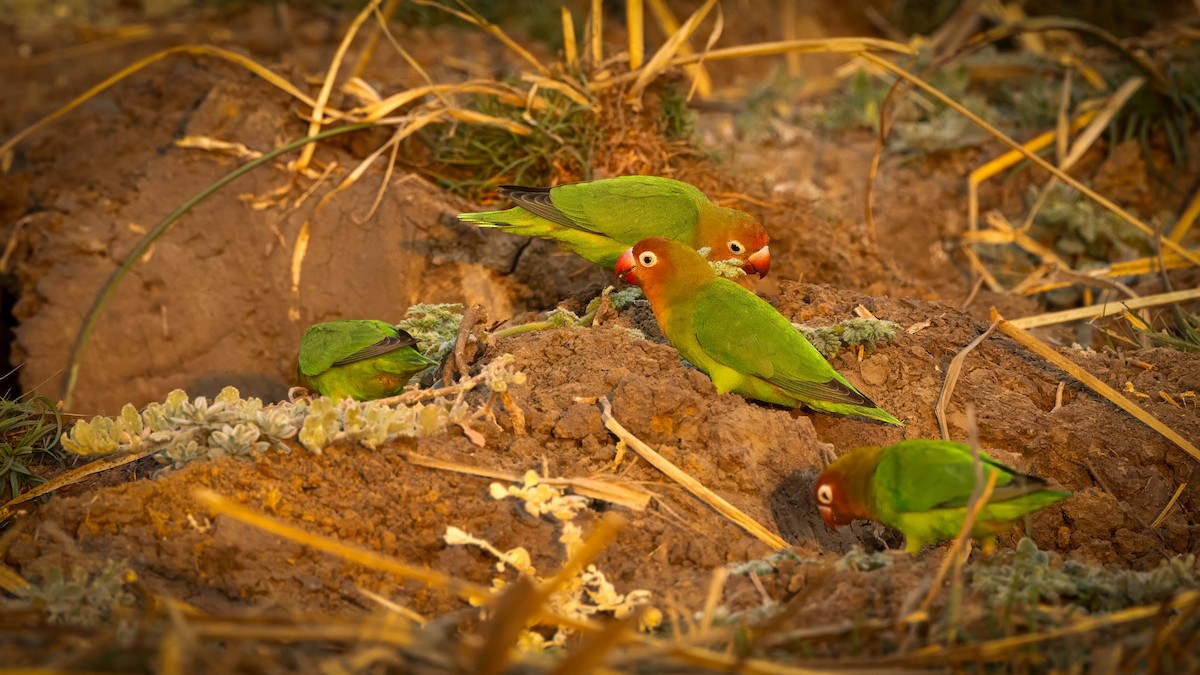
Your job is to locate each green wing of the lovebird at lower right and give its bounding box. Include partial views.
[871,441,1046,512]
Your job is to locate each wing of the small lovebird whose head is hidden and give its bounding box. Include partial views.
[299,319,416,377]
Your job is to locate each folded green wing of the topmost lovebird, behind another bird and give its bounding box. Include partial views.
[500,175,708,245]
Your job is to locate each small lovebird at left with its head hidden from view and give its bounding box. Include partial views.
[296,319,437,401]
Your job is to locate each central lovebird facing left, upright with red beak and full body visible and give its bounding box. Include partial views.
[616,237,904,425]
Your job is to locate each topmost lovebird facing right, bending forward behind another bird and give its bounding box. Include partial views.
[458,175,770,276]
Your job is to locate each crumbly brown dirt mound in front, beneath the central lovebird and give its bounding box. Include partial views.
[7,283,1200,614]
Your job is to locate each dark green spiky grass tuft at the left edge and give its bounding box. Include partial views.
[0,396,62,501]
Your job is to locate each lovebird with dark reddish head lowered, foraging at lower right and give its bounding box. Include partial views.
[812,441,1070,554]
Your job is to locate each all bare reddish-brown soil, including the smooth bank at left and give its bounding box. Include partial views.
[0,1,1200,667]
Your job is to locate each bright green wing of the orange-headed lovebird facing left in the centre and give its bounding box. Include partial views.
[695,279,874,406]
